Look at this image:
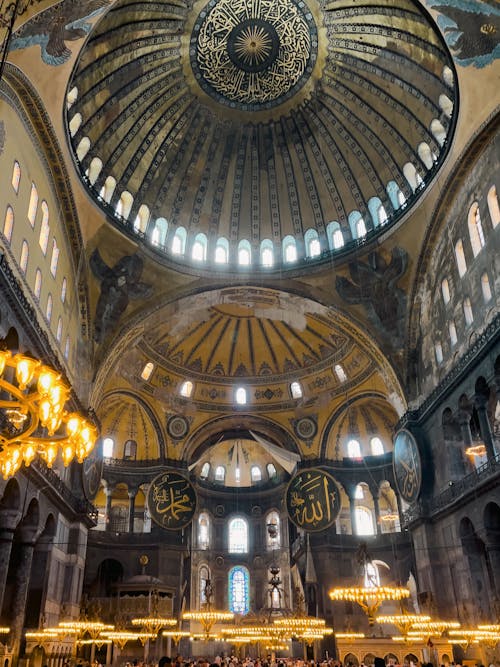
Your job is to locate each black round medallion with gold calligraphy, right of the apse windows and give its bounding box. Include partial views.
[285,468,341,532]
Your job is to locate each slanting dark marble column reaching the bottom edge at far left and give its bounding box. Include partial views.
[10,527,35,667]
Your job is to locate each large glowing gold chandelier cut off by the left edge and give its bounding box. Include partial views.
[0,350,97,479]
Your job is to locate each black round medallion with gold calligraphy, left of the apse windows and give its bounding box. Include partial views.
[147,472,196,530]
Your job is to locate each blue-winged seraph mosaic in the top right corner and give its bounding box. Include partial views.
[428,0,500,67]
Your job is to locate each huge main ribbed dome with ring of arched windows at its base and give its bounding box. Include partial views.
[68,0,456,270]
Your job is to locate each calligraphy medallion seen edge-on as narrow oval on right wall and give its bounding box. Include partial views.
[393,429,422,504]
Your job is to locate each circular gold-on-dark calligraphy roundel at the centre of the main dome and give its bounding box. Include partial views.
[189,0,318,111]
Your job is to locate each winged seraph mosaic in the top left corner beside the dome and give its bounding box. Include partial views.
[10,0,111,66]
